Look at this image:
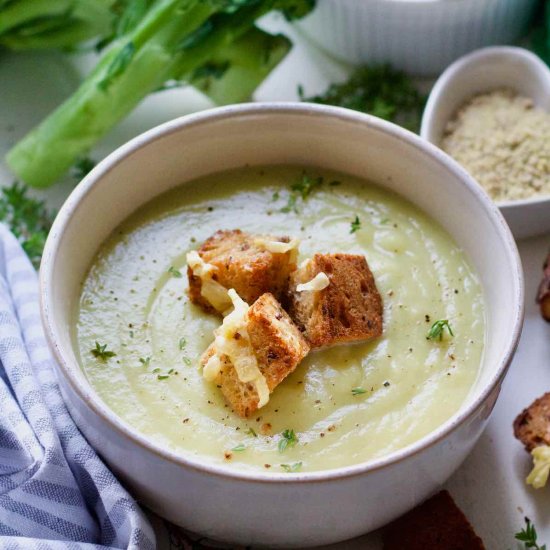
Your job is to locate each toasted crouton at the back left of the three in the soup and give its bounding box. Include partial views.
[187,229,298,313]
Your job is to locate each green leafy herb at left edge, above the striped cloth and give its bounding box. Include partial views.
[0,182,53,268]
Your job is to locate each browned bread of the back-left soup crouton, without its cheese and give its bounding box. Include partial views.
[187,229,296,312]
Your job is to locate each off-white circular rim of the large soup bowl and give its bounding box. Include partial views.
[39,102,524,484]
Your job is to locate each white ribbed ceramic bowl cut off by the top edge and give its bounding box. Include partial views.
[297,0,538,75]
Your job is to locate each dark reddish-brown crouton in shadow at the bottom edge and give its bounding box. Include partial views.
[382,491,485,550]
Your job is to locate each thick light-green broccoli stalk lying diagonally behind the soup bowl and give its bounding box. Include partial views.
[6,0,313,187]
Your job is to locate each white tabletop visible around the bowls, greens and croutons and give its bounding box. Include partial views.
[0,12,550,550]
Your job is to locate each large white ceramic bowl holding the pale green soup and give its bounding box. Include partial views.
[40,103,523,547]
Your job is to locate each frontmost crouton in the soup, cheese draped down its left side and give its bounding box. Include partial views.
[201,290,309,417]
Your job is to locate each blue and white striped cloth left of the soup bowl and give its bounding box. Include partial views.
[0,224,155,550]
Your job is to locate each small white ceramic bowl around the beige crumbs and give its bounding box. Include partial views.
[420,47,550,243]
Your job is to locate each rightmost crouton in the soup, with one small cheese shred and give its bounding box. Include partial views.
[287,254,382,348]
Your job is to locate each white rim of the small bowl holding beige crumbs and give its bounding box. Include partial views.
[422,44,550,210]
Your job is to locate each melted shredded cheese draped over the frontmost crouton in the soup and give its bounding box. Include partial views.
[203,289,269,408]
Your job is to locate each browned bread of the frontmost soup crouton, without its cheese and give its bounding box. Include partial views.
[201,293,309,417]
